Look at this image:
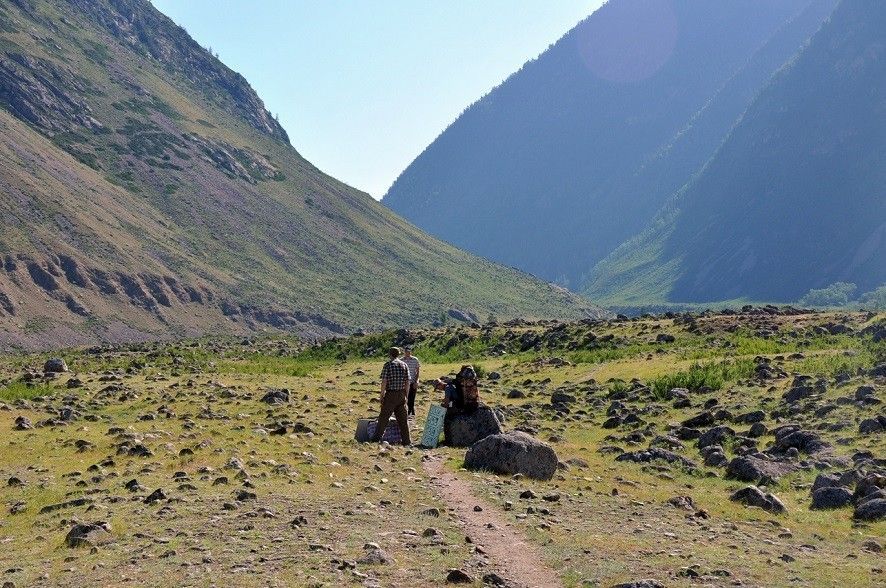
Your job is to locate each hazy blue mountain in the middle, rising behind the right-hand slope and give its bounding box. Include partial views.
[383,0,836,288]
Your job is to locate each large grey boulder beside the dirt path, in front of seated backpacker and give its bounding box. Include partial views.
[465,431,557,480]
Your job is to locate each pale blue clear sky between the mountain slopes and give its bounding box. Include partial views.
[153,0,603,198]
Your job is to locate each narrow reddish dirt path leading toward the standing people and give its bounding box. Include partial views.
[422,454,562,588]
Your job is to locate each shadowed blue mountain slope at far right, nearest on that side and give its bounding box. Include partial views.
[587,0,886,302]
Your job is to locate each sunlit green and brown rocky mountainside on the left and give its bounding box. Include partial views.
[0,0,596,347]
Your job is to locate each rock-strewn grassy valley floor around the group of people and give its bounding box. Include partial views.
[0,307,886,587]
